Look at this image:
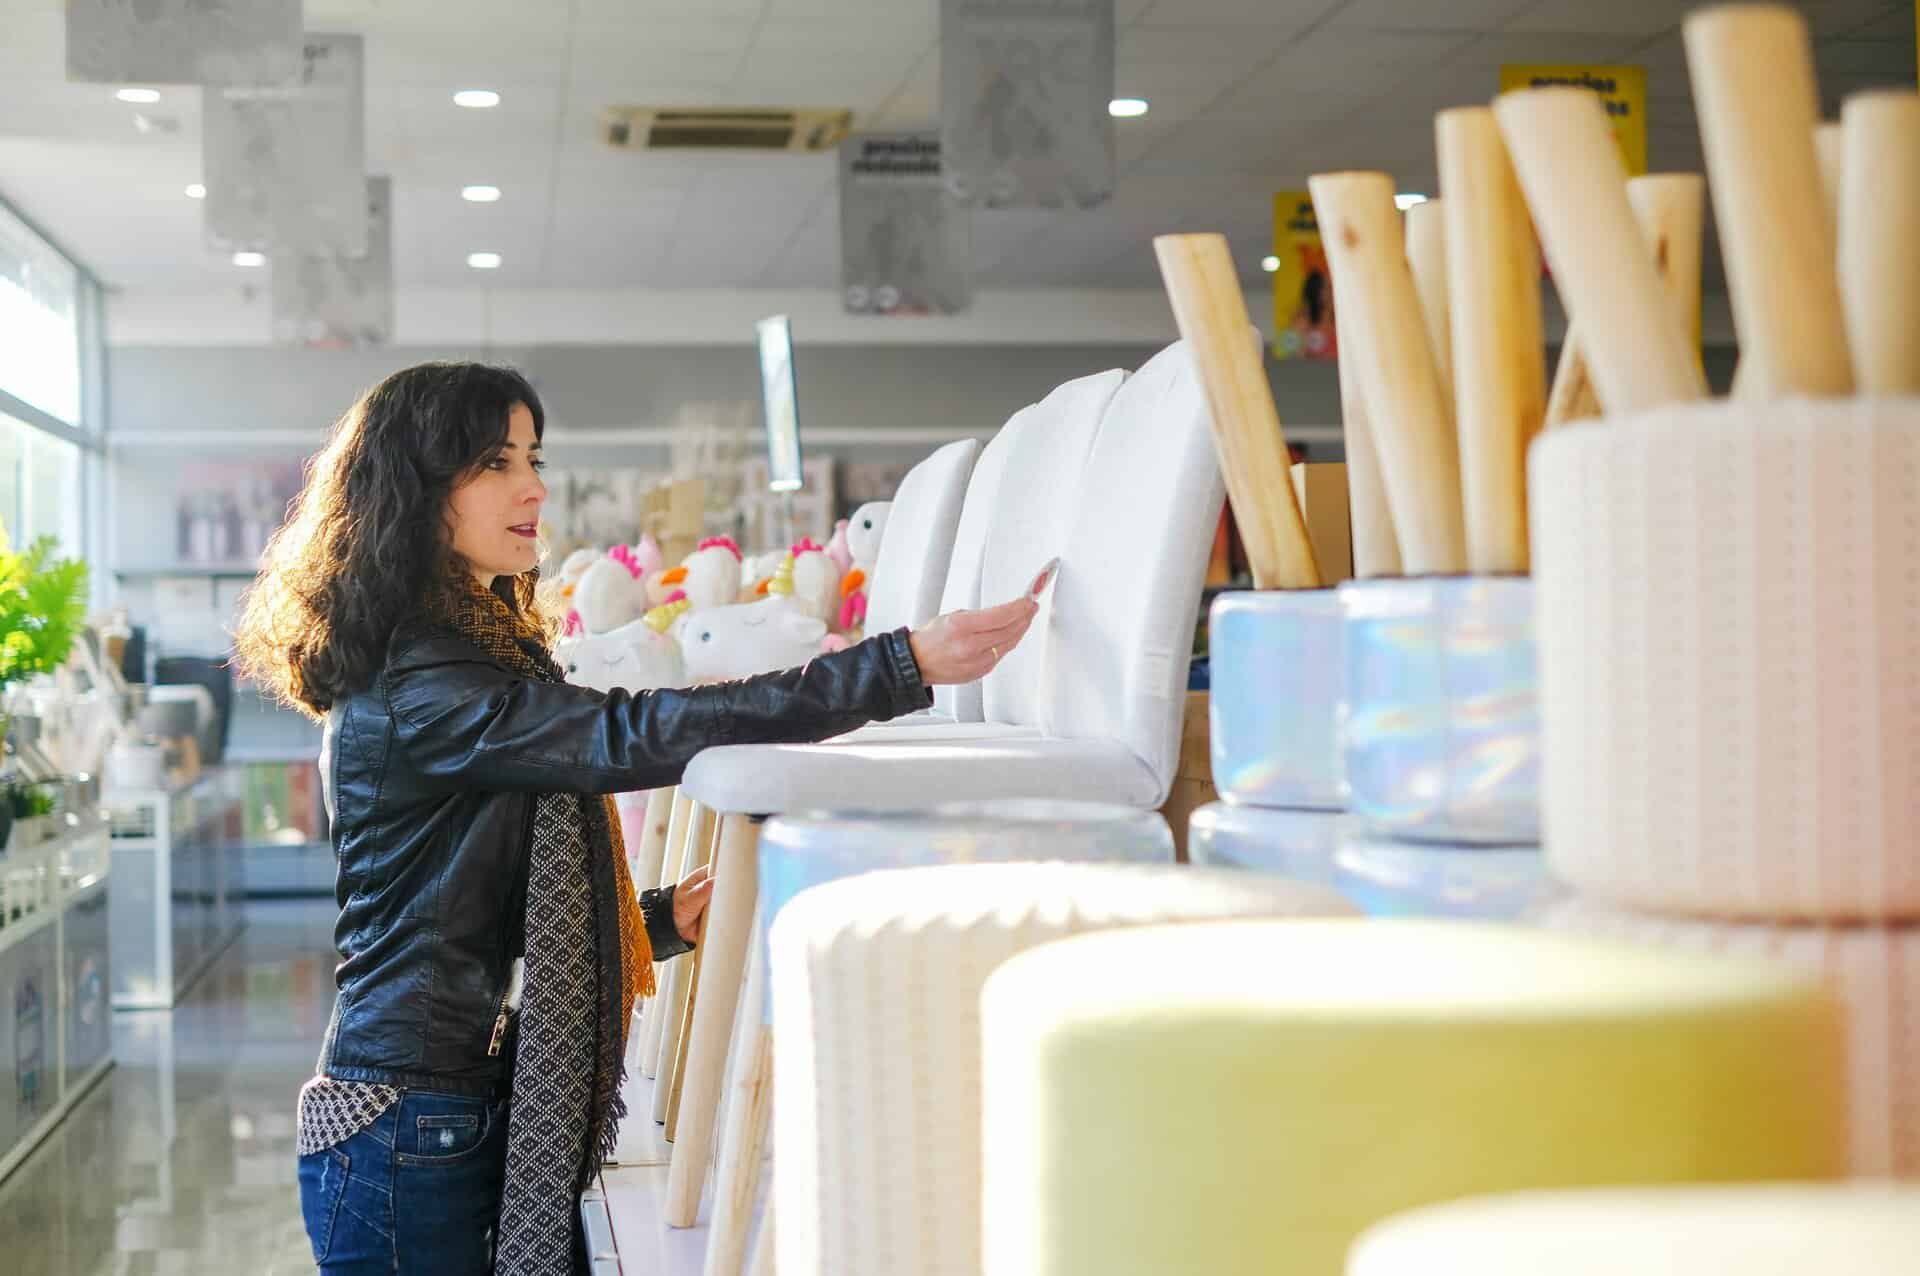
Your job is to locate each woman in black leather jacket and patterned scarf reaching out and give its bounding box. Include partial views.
[236,363,1035,1274]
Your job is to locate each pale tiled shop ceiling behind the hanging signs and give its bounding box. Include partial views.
[0,0,1914,294]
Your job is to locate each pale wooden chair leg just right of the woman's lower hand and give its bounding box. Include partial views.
[662,815,760,1228]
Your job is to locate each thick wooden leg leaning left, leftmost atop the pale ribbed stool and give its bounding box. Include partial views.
[1494,88,1707,416]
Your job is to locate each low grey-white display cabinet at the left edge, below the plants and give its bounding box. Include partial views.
[0,812,113,1180]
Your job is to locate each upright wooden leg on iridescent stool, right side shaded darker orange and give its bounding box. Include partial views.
[1434,106,1548,576]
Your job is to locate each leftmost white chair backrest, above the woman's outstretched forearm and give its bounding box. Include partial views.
[866,439,979,633]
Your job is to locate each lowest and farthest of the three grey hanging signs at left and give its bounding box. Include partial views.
[273,177,394,349]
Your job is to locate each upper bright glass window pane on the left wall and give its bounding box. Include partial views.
[0,207,81,426]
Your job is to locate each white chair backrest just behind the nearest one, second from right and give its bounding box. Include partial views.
[979,368,1127,727]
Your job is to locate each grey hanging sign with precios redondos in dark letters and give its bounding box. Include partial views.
[839,132,972,315]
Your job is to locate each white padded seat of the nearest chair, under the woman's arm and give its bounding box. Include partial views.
[680,723,1160,815]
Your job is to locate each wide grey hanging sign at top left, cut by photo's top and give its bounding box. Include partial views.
[67,0,301,86]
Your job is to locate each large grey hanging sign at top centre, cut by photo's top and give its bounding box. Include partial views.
[941,0,1114,207]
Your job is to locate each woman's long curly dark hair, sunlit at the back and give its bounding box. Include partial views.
[234,363,547,718]
